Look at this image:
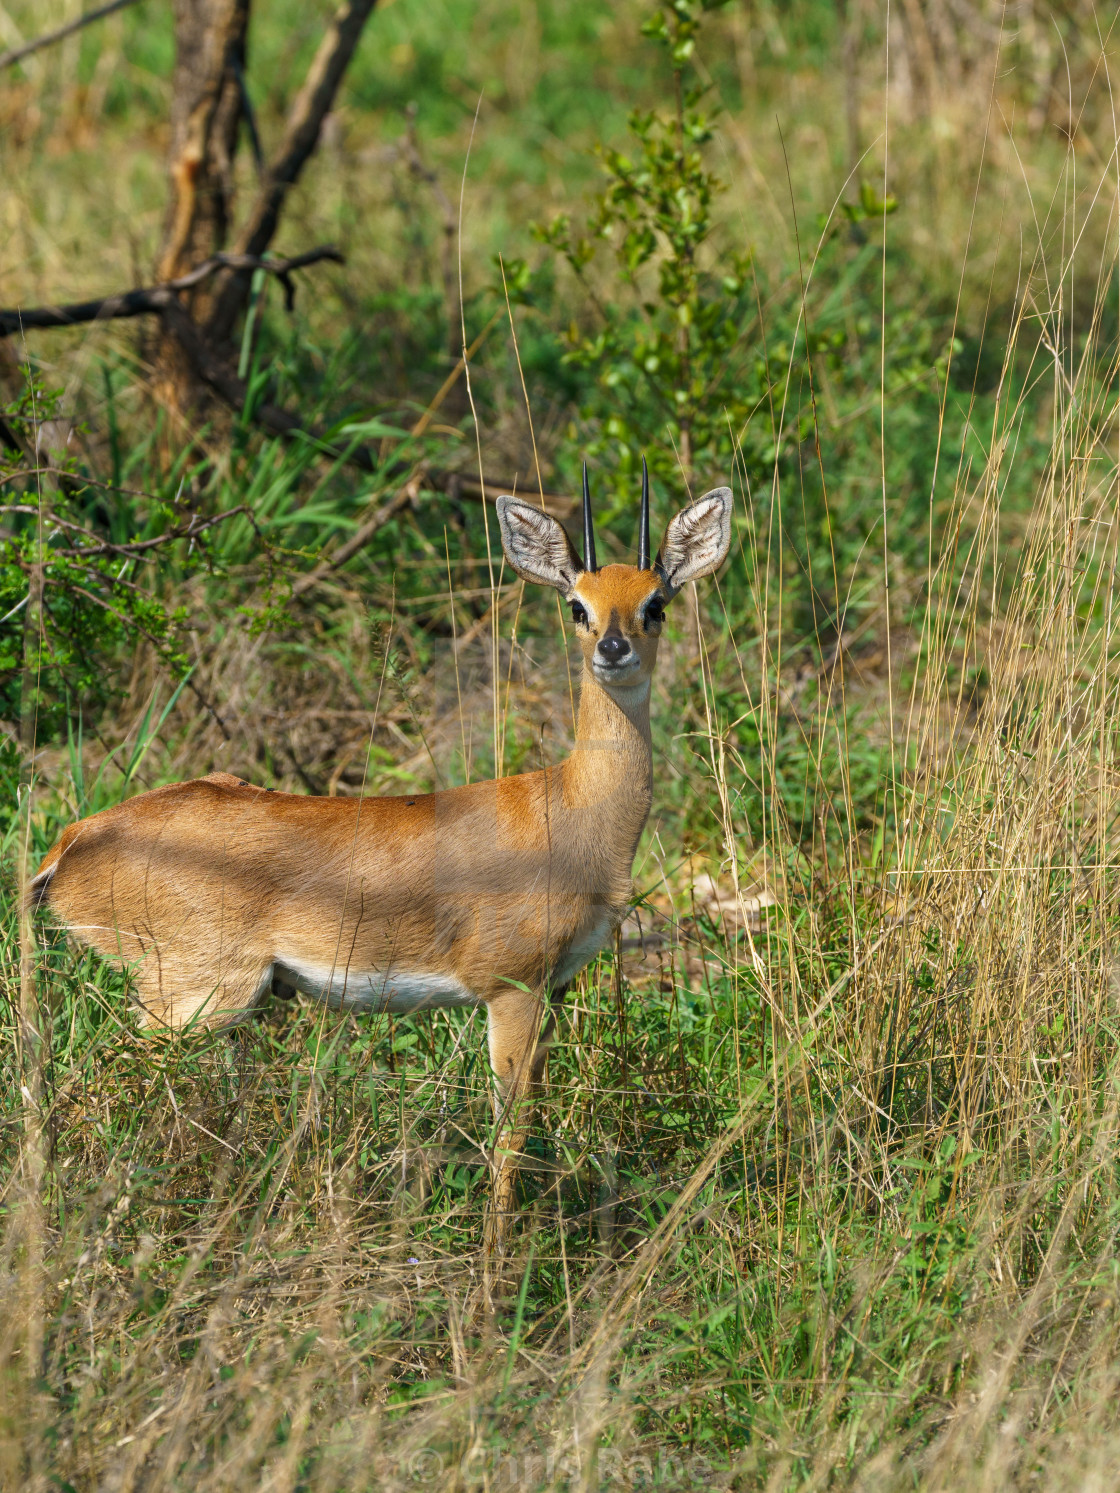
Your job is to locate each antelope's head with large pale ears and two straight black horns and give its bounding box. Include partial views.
[497,460,732,699]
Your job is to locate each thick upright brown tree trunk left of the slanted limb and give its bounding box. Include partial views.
[154,0,251,415]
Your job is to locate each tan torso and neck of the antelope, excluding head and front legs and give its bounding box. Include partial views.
[36,650,651,1027]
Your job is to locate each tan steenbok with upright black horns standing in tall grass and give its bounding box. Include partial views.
[31,472,732,1239]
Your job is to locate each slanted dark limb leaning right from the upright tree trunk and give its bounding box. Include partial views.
[206,0,376,343]
